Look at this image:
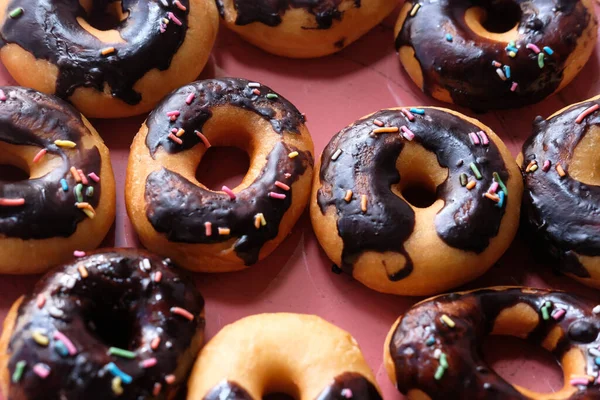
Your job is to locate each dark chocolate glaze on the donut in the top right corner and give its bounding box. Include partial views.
[396,0,595,110]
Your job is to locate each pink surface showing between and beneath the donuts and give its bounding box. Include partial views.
[0,5,600,399]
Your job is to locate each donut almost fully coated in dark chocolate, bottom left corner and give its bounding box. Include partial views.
[0,249,205,400]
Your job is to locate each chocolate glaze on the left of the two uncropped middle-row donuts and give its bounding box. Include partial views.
[145,78,313,265]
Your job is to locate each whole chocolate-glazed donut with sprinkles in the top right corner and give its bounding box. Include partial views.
[394,0,598,111]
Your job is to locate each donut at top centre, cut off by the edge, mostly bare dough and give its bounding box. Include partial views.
[216,0,397,58]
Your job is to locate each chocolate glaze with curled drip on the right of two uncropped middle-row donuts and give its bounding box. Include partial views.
[317,108,510,280]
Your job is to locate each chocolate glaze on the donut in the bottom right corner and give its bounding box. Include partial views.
[389,288,600,400]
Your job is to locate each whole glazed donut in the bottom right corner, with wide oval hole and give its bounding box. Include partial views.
[384,286,600,400]
